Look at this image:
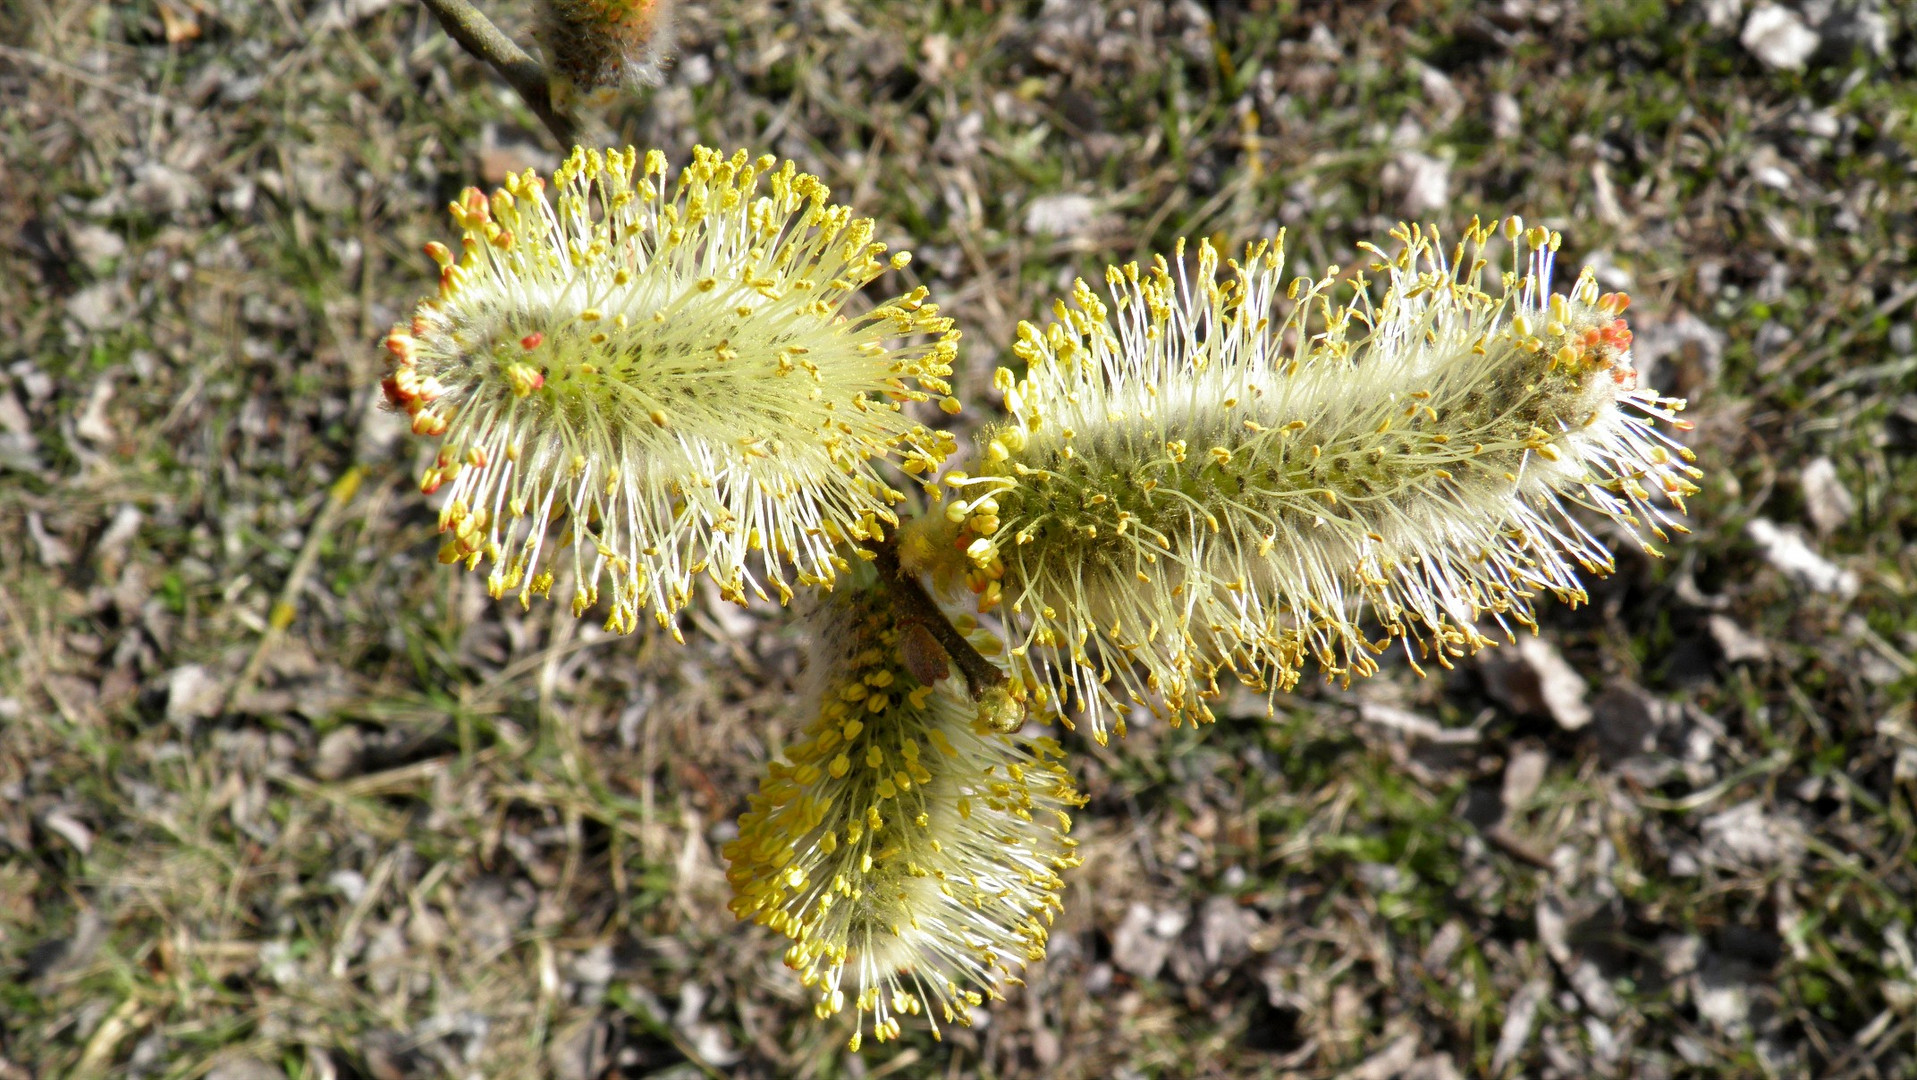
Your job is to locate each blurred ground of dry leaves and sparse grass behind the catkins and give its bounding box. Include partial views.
[0,0,1917,1080]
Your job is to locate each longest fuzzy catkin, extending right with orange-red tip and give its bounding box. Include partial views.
[901,219,1700,740]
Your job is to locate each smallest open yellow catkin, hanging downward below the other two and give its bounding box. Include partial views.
[725,581,1085,1049]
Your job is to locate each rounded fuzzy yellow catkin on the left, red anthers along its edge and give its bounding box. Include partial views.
[383,148,959,635]
